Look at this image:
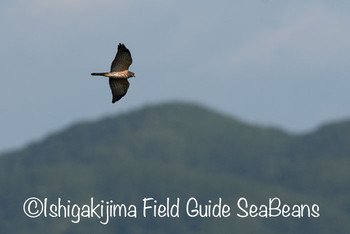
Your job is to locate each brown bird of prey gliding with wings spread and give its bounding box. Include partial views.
[91,43,135,103]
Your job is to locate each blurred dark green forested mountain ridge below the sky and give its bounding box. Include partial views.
[0,103,350,234]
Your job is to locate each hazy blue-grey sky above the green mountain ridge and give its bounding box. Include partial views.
[0,0,350,152]
